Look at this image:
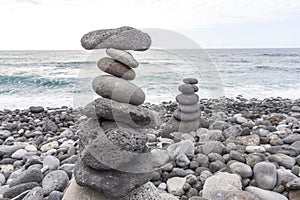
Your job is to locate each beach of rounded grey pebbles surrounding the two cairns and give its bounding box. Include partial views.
[0,96,300,200]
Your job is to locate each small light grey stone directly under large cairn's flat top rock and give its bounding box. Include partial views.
[106,48,139,68]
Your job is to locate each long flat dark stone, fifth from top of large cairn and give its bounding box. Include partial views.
[83,98,161,128]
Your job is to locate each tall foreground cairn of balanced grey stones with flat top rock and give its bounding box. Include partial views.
[66,27,161,200]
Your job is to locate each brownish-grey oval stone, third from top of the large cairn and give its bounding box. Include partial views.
[97,58,135,80]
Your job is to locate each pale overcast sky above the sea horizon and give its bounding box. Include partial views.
[0,0,300,50]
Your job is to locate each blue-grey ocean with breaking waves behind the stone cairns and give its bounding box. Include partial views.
[0,49,300,109]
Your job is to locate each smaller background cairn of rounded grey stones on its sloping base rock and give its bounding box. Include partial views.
[162,78,201,138]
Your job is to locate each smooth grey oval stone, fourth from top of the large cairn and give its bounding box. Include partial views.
[93,75,145,105]
